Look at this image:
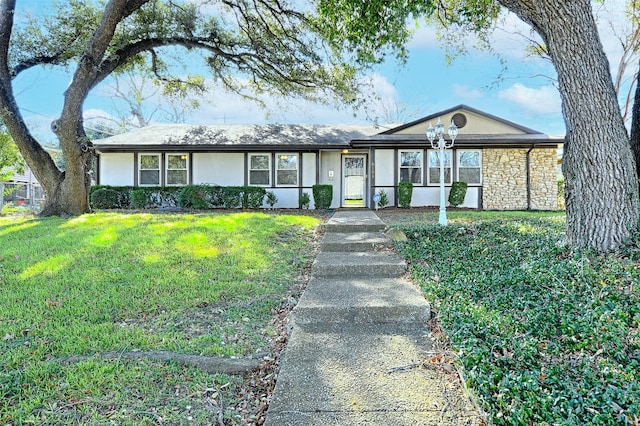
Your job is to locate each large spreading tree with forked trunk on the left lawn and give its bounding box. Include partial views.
[0,0,358,215]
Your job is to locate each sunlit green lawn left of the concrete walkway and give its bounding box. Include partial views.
[0,213,319,425]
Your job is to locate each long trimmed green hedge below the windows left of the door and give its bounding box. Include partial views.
[90,185,267,210]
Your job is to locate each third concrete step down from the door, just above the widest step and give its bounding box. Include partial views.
[312,252,407,279]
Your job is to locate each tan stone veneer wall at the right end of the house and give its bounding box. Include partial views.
[482,148,558,210]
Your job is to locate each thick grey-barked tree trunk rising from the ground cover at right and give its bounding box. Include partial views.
[500,0,640,251]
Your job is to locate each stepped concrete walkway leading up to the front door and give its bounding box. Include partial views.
[265,210,478,426]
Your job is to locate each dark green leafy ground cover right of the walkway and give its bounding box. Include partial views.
[398,212,640,425]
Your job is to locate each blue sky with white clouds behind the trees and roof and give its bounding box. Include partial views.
[15,0,624,142]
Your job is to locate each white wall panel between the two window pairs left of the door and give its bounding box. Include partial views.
[193,152,244,186]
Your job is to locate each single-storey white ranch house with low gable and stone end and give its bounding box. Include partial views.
[95,105,564,210]
